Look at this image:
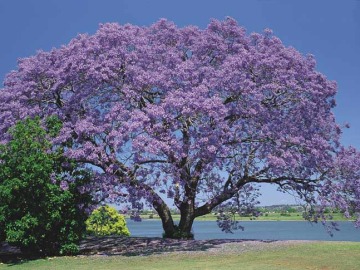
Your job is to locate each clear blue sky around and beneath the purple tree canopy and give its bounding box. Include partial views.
[0,0,360,204]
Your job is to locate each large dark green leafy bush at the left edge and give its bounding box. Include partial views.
[0,117,91,255]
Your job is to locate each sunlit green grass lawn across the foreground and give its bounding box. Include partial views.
[0,242,360,270]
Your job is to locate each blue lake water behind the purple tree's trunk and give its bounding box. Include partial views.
[127,220,360,242]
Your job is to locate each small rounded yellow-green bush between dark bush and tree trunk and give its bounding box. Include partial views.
[86,205,130,236]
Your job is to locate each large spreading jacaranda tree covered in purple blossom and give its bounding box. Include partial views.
[0,18,360,237]
